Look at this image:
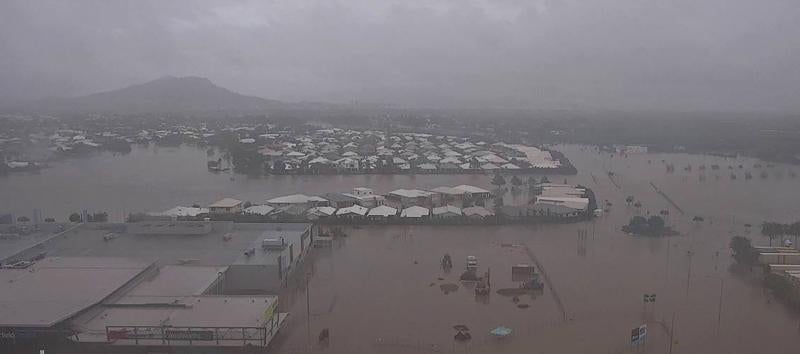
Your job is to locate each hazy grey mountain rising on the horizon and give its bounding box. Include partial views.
[24,76,286,114]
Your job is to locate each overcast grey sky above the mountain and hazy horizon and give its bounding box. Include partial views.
[0,0,800,112]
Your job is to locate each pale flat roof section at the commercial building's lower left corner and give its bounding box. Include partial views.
[0,257,152,327]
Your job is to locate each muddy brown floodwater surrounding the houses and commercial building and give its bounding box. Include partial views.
[0,146,800,353]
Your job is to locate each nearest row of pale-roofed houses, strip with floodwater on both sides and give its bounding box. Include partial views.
[151,183,589,221]
